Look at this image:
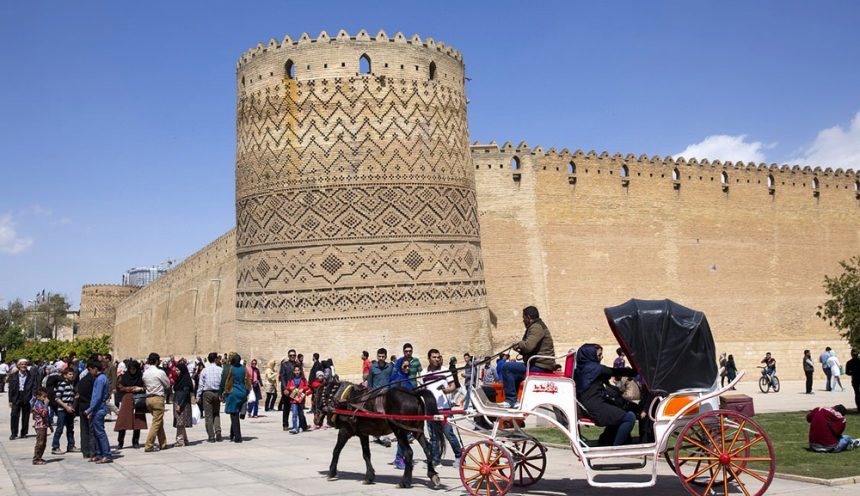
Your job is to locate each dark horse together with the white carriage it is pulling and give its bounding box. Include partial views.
[317,300,775,496]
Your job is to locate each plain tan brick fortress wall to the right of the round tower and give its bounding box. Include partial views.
[472,143,860,378]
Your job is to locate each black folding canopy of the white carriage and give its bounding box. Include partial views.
[603,299,717,394]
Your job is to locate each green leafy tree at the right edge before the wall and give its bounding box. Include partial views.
[816,255,860,348]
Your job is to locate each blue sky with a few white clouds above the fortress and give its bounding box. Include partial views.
[0,1,860,306]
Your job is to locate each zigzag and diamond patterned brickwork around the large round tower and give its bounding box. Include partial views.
[236,49,486,322]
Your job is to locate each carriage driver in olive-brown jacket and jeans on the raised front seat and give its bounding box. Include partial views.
[499,306,555,408]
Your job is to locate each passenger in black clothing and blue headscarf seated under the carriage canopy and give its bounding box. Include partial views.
[573,344,639,446]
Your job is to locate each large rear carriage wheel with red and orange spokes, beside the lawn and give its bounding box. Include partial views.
[674,410,775,496]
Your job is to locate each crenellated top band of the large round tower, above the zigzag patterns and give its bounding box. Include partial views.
[236,30,465,94]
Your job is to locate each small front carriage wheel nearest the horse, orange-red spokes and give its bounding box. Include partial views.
[460,440,514,496]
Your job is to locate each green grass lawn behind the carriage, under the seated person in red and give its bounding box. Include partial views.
[528,412,860,479]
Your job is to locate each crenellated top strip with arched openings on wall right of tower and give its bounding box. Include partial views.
[471,141,860,199]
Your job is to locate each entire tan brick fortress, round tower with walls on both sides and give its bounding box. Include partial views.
[81,31,860,378]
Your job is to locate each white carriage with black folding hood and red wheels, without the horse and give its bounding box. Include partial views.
[457,300,775,496]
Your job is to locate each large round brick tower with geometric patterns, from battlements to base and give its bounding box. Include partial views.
[236,31,490,358]
